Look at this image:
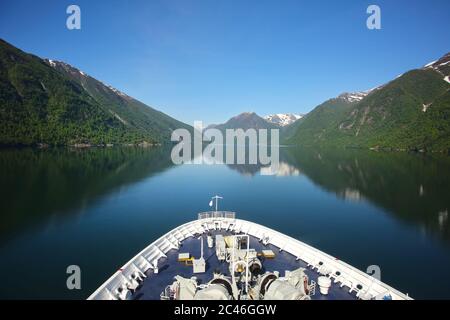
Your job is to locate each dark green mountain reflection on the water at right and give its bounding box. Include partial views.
[280,148,450,240]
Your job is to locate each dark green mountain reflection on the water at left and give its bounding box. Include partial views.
[0,147,172,238]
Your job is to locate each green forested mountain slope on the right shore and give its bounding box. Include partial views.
[284,53,450,151]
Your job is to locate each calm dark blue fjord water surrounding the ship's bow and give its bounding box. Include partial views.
[0,148,450,299]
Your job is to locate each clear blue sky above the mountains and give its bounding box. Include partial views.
[0,0,450,124]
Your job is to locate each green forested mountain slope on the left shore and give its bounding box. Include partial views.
[0,39,191,146]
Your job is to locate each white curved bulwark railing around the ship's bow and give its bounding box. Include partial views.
[88,215,411,300]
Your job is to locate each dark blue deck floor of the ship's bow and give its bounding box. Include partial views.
[132,230,357,300]
